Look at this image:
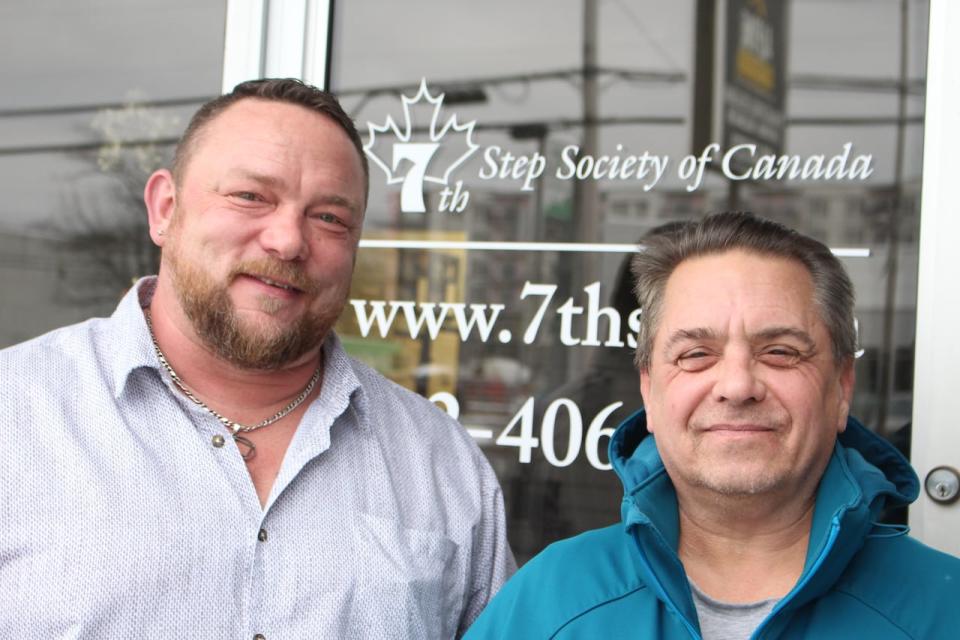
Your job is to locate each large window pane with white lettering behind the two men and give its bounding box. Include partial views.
[332,0,928,560]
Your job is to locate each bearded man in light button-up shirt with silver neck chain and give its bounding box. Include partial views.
[0,80,514,640]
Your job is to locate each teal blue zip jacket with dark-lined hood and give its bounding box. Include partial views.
[466,411,960,640]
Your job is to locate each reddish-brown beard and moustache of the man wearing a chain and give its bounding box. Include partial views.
[168,252,347,370]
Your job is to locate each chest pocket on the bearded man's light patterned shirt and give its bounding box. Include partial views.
[352,513,464,639]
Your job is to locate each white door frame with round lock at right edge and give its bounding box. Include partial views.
[910,0,960,555]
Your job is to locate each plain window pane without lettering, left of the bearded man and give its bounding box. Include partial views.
[0,0,226,347]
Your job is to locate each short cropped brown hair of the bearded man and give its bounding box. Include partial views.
[171,78,370,199]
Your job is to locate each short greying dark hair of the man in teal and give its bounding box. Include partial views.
[631,212,857,371]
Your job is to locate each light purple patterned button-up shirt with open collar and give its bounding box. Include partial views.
[0,279,514,640]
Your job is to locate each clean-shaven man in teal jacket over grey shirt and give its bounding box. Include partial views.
[467,213,960,640]
